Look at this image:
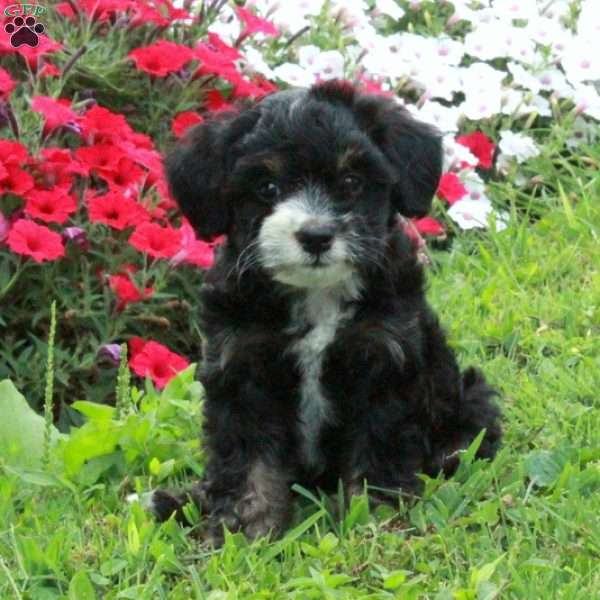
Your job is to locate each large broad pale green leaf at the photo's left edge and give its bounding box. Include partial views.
[0,379,61,469]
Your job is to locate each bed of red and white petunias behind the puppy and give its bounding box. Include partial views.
[0,0,600,424]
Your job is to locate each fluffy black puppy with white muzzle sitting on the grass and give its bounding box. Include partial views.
[151,81,501,543]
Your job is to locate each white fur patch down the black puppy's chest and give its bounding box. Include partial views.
[291,288,355,465]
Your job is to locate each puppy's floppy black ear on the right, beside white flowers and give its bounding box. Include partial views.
[353,95,442,217]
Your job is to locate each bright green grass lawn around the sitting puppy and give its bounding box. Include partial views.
[0,155,600,600]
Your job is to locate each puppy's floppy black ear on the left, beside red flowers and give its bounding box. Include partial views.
[165,110,258,240]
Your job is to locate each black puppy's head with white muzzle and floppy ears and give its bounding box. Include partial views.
[167,82,442,287]
